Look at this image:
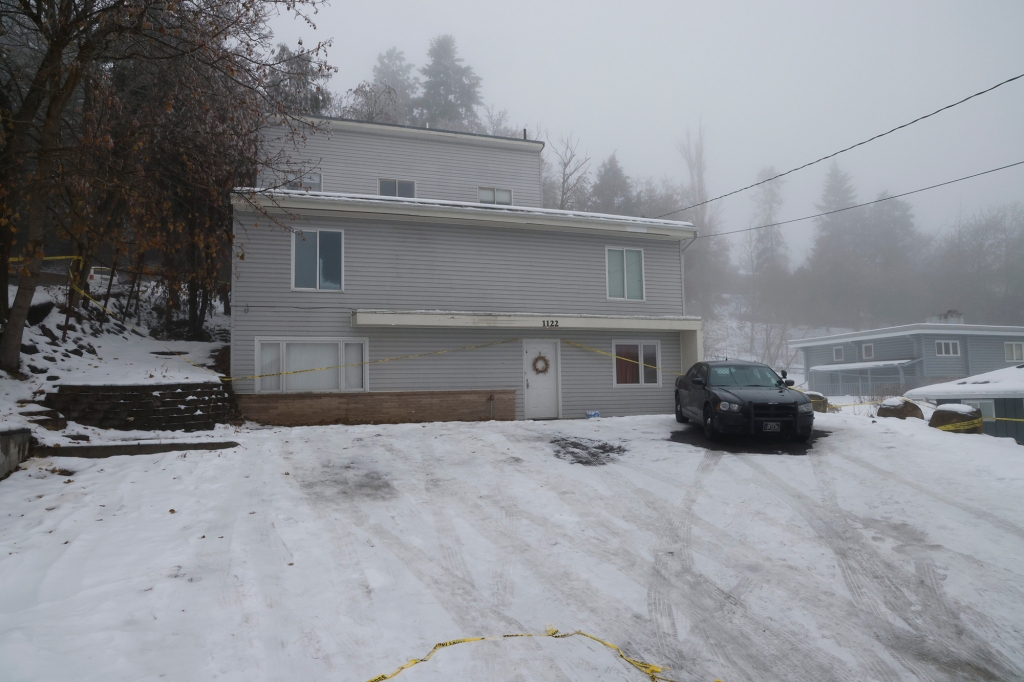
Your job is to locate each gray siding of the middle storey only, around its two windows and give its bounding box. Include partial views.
[232,215,682,319]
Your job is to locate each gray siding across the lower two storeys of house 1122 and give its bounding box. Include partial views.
[231,213,682,405]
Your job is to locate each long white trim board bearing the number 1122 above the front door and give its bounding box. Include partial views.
[352,310,703,332]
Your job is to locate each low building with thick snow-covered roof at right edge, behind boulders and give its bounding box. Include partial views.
[906,364,1024,445]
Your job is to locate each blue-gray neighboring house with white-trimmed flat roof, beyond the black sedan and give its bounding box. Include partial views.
[788,323,1024,395]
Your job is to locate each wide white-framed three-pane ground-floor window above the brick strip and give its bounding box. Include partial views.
[256,339,369,393]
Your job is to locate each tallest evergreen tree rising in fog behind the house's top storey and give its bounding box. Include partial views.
[415,35,482,131]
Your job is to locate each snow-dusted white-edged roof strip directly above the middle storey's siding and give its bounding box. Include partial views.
[232,187,696,240]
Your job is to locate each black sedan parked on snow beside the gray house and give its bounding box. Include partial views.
[676,360,814,440]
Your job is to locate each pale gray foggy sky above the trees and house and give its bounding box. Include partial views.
[274,0,1024,261]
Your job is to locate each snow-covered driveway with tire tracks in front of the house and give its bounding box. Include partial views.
[0,414,1024,682]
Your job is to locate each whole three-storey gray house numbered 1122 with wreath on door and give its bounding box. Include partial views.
[231,121,702,424]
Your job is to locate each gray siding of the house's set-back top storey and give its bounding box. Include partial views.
[266,128,542,206]
